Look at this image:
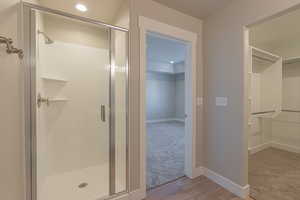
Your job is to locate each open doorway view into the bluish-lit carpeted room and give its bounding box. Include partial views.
[146,33,187,189]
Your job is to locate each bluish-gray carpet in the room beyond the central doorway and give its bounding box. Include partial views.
[147,122,185,189]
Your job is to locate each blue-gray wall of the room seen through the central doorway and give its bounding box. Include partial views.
[146,72,185,120]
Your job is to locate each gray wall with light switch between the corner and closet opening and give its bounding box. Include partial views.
[203,0,300,186]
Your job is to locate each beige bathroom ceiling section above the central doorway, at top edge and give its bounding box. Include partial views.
[154,0,232,19]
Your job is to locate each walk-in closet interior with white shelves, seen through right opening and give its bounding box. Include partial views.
[247,7,300,200]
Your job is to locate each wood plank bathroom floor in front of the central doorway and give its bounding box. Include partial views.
[145,176,251,200]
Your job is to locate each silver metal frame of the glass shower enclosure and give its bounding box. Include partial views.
[20,2,130,200]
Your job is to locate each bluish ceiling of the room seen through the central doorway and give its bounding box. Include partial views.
[147,34,186,64]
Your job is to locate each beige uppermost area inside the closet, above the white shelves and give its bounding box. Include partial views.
[250,10,300,54]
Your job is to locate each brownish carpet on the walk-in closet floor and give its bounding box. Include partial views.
[249,148,300,200]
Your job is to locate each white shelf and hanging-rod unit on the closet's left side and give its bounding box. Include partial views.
[248,47,282,119]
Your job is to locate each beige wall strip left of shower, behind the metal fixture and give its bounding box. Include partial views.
[0,0,25,200]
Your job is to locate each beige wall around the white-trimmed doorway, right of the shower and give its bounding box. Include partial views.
[129,0,203,190]
